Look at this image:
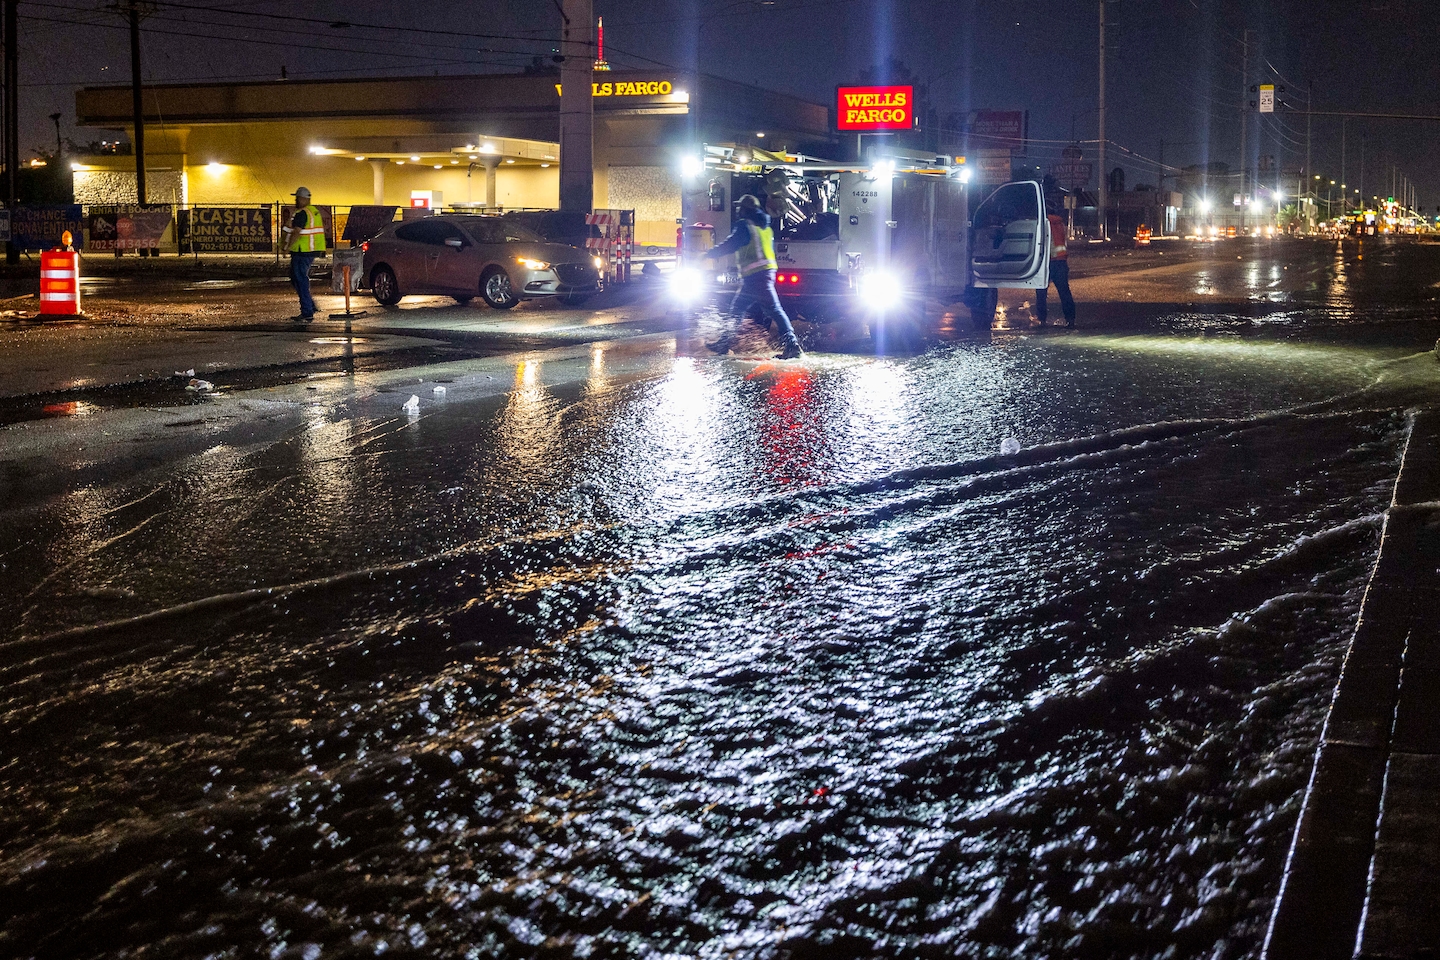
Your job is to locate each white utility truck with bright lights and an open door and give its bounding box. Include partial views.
[675,145,1050,333]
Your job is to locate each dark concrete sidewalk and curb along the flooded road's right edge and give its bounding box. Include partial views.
[1264,410,1440,960]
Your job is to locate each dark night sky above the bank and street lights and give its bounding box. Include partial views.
[20,0,1440,209]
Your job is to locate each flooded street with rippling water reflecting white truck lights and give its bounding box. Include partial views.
[0,242,1440,960]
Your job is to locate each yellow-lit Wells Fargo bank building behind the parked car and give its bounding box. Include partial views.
[72,71,838,245]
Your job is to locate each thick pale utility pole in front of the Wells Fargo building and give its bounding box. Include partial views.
[560,0,595,213]
